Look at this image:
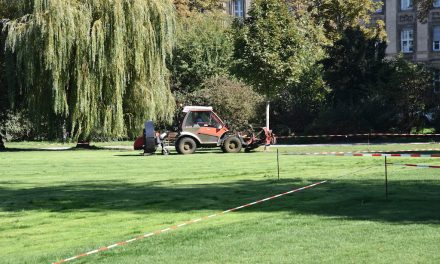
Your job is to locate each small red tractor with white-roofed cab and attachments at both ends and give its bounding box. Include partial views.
[134,106,276,155]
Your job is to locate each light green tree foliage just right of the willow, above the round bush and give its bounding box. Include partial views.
[170,13,233,94]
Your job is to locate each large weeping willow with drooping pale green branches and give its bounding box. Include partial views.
[4,0,175,140]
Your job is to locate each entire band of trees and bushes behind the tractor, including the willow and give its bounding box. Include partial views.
[0,0,440,147]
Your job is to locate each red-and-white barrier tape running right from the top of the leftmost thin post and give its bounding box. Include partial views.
[285,150,440,158]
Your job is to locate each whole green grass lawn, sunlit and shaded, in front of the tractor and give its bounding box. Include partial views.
[0,143,440,263]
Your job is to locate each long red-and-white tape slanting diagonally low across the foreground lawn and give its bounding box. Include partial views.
[53,181,327,264]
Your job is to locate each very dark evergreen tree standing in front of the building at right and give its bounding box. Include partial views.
[313,27,387,133]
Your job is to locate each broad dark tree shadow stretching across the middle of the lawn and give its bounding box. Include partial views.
[0,178,440,224]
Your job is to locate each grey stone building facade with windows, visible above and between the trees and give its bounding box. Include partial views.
[227,0,440,68]
